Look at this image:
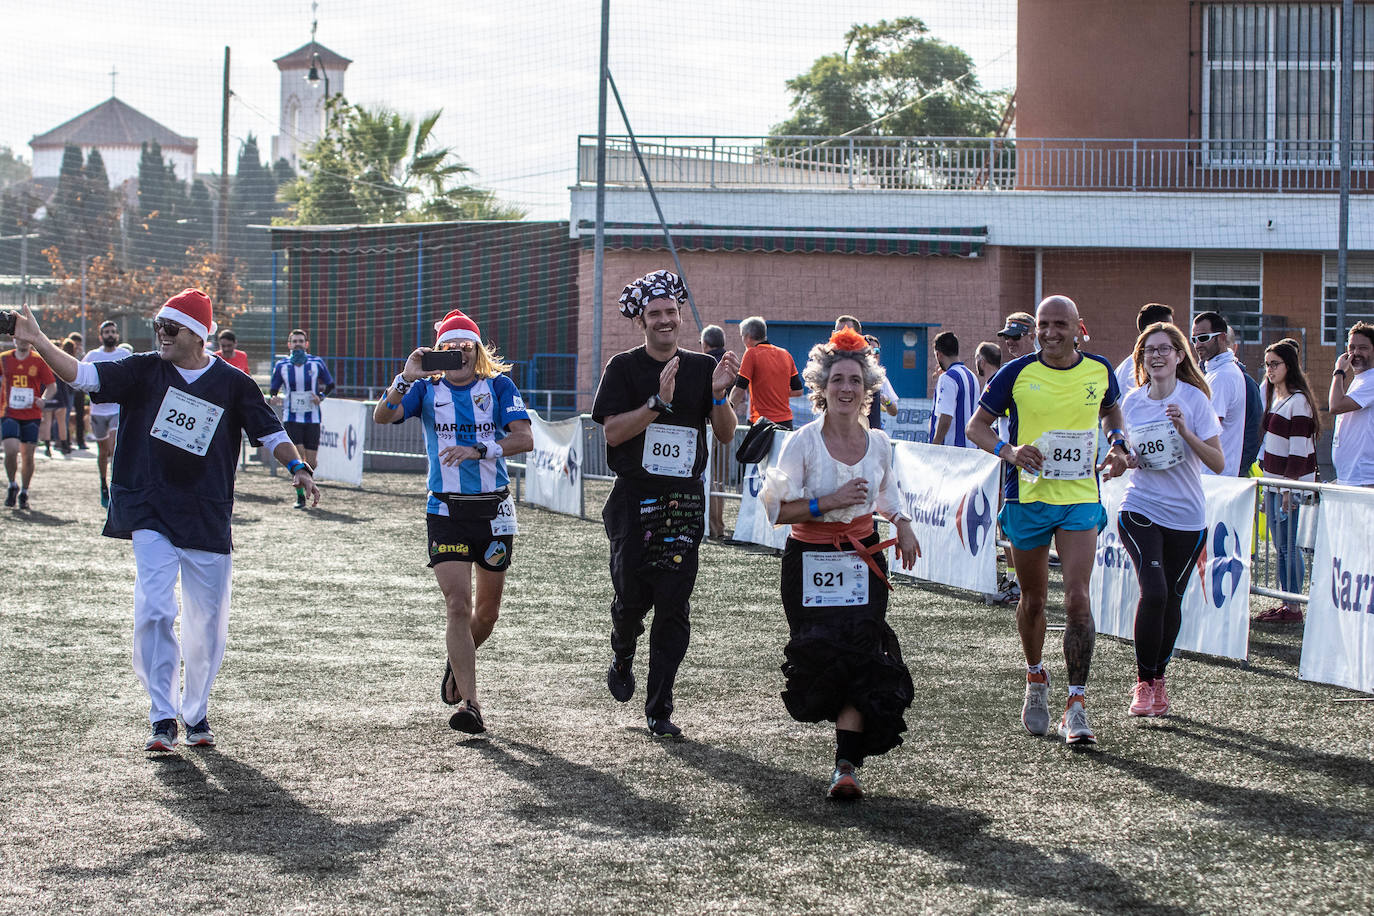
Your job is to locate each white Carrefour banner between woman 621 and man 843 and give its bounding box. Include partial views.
[888,441,1002,593]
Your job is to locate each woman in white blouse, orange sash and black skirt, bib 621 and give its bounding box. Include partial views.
[761,328,921,799]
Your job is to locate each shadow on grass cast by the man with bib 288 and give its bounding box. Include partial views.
[54,750,409,878]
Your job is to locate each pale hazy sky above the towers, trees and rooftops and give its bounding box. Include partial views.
[0,0,1015,220]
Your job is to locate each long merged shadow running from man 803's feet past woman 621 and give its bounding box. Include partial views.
[664,742,1187,916]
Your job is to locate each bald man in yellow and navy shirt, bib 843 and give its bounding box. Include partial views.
[967,295,1127,744]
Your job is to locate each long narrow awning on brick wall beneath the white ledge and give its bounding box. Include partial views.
[577,220,988,258]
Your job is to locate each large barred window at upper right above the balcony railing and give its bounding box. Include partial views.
[1202,3,1374,166]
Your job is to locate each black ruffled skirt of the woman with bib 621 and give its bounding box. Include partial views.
[782,534,915,754]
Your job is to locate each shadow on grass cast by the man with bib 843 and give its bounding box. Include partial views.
[1094,747,1374,840]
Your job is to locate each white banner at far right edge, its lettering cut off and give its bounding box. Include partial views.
[1297,489,1374,694]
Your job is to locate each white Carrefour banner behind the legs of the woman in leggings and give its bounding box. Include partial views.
[1088,475,1254,659]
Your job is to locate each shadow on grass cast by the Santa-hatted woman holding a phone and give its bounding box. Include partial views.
[467,737,687,836]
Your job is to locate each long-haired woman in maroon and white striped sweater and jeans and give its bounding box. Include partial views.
[1254,338,1322,623]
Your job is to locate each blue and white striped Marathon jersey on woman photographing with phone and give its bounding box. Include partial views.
[396,375,529,515]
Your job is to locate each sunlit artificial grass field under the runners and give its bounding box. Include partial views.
[0,457,1374,913]
